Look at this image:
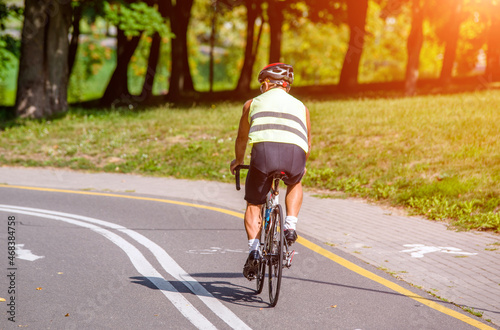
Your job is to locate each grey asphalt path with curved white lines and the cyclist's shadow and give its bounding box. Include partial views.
[0,187,488,329]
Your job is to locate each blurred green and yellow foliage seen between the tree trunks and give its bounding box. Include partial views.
[0,0,499,104]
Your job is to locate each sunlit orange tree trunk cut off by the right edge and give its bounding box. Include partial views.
[485,8,500,82]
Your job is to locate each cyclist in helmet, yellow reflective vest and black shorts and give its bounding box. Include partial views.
[230,63,311,279]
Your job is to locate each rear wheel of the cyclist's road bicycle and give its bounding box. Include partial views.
[266,204,284,307]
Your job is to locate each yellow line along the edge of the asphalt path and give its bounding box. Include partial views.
[0,184,495,330]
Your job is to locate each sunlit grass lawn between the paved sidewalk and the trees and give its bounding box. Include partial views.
[0,90,500,232]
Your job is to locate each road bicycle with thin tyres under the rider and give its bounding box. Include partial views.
[235,165,295,307]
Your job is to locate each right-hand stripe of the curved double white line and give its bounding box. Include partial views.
[0,204,251,329]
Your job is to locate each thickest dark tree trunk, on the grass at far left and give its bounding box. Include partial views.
[15,0,71,118]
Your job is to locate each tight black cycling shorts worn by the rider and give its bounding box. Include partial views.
[245,142,306,205]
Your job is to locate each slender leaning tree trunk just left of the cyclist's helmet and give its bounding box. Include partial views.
[235,0,261,93]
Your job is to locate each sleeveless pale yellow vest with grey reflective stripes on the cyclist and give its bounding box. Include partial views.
[248,88,309,153]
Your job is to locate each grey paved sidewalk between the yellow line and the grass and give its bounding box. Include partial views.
[0,167,500,327]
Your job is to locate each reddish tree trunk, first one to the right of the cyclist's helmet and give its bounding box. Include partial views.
[339,0,368,90]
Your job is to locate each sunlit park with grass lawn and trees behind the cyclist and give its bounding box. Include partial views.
[0,0,500,231]
